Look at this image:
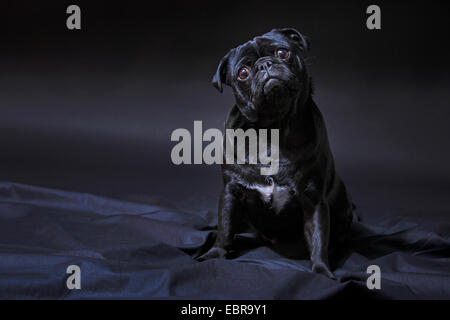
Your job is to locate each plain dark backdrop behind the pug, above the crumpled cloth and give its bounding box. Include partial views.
[0,1,450,217]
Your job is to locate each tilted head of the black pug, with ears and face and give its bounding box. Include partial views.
[212,28,310,125]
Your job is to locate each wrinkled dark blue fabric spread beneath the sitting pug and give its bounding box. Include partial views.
[0,182,450,299]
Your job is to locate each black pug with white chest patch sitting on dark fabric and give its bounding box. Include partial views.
[198,28,353,278]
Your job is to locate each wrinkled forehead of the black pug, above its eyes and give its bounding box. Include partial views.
[230,32,291,65]
